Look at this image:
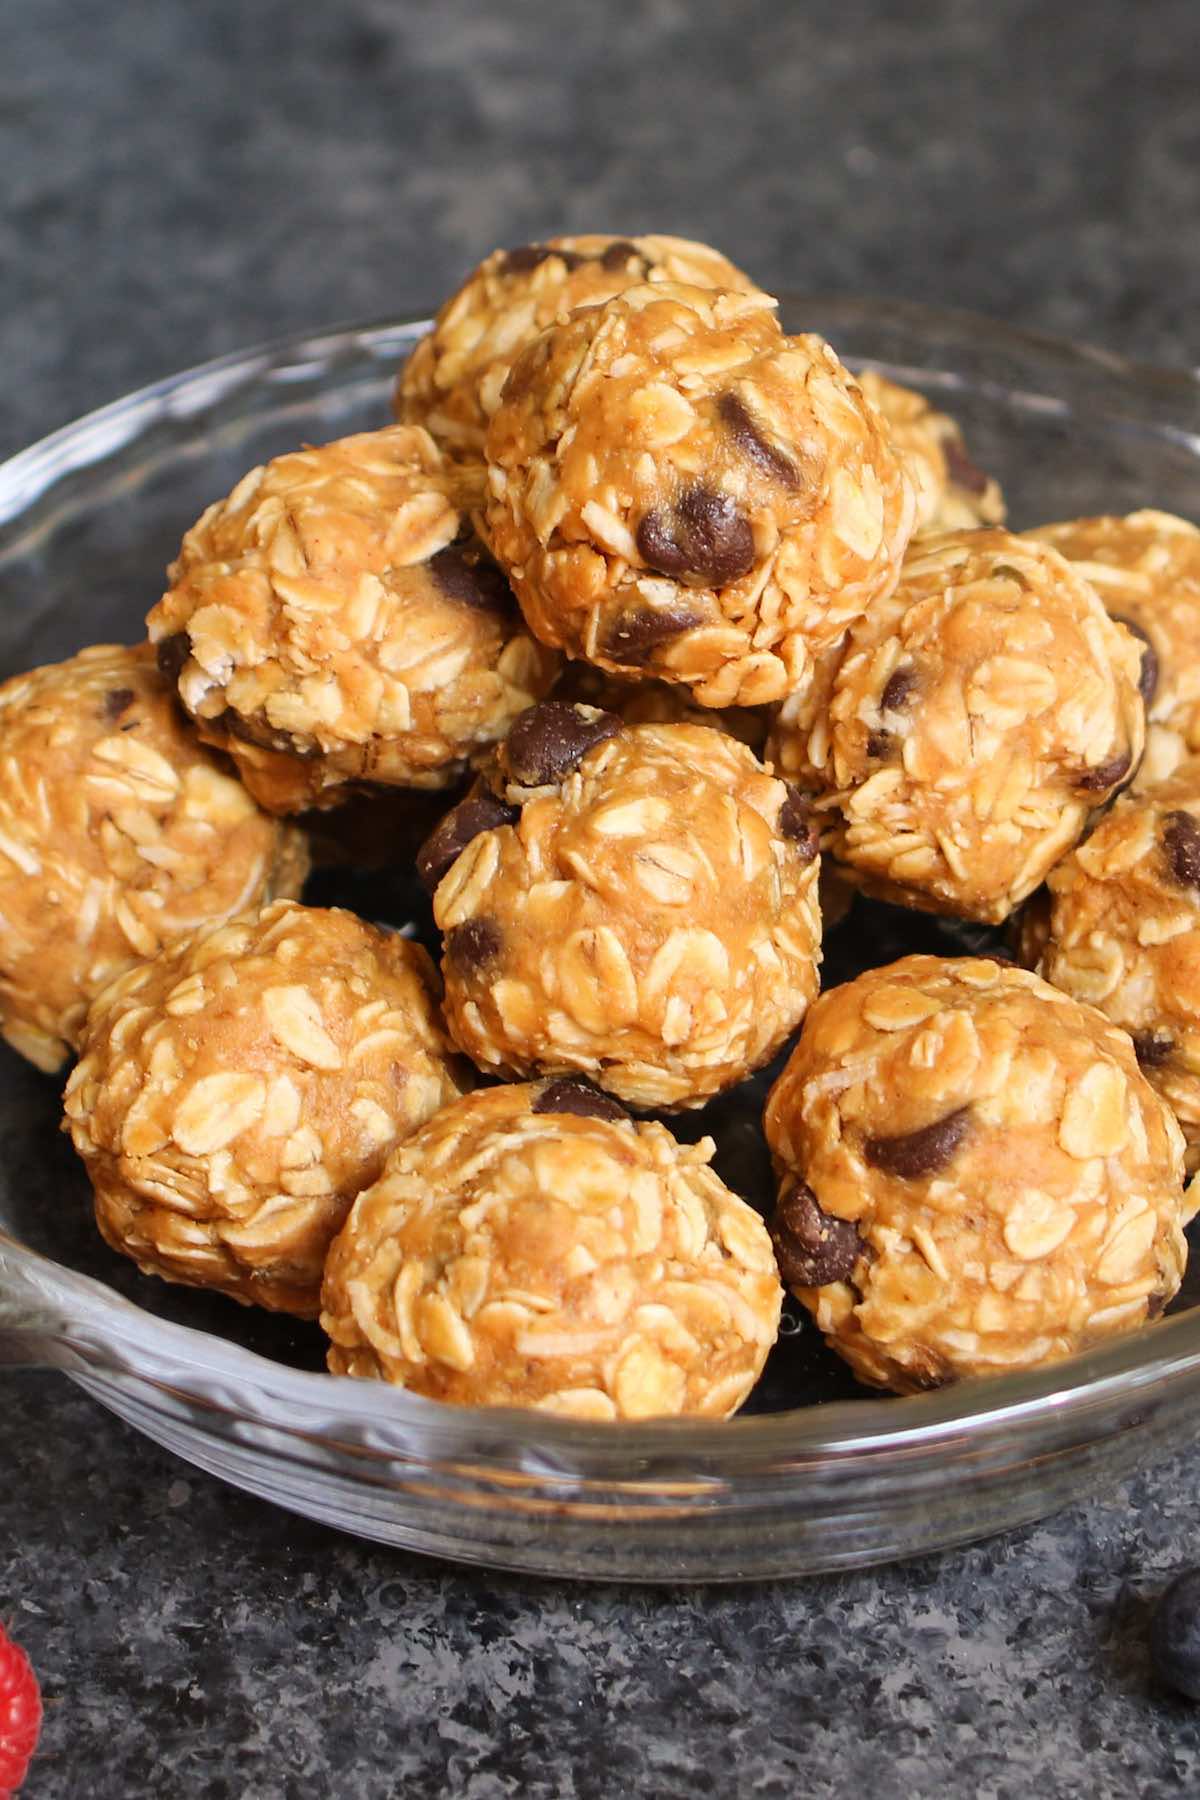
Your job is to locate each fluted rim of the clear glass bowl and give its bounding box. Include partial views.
[0,295,1200,1503]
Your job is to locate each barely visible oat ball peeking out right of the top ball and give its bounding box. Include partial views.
[858,369,1004,531]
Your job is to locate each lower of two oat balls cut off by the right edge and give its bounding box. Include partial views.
[1025,756,1200,1168]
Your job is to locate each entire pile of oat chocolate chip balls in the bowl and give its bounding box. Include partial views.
[0,236,1200,1420]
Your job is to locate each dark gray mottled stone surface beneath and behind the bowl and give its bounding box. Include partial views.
[0,0,1200,1800]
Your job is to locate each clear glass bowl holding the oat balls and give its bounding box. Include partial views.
[0,299,1200,1580]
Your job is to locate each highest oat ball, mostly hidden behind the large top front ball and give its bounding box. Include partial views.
[396,234,759,463]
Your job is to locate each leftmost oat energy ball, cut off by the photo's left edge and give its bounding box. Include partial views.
[0,644,308,1071]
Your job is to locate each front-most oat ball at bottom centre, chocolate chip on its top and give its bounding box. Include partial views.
[320,1082,783,1420]
